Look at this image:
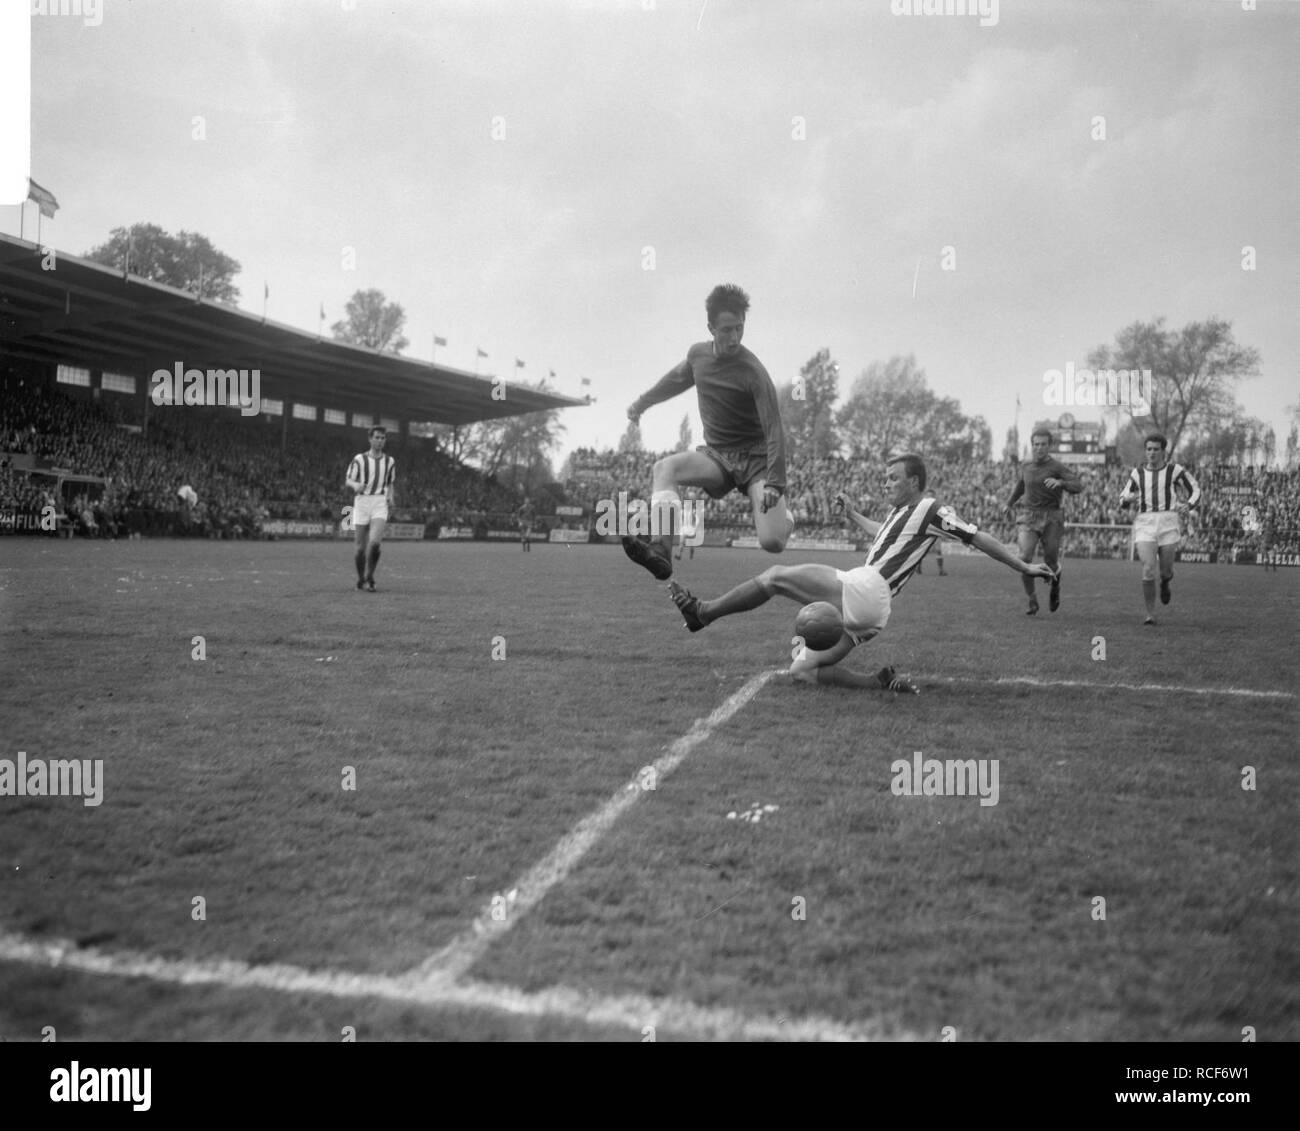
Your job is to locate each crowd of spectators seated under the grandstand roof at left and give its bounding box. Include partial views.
[0,382,521,538]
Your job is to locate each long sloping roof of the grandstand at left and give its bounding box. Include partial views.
[0,233,588,424]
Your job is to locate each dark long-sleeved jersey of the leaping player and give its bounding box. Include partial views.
[633,342,785,491]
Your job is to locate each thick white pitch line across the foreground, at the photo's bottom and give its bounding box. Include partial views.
[0,932,924,1041]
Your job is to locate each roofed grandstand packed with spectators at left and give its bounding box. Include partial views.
[0,234,588,537]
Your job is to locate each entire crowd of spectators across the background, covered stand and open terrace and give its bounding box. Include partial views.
[0,382,1300,558]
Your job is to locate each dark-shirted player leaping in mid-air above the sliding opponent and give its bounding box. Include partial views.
[623,283,794,581]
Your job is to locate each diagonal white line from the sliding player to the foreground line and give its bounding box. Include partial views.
[411,670,779,982]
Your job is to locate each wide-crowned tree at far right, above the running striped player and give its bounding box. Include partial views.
[1088,316,1260,450]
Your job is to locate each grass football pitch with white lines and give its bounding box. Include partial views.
[0,538,1300,1041]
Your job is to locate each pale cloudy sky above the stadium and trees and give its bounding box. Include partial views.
[0,0,1300,467]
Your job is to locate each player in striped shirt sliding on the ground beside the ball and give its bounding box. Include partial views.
[668,455,1052,693]
